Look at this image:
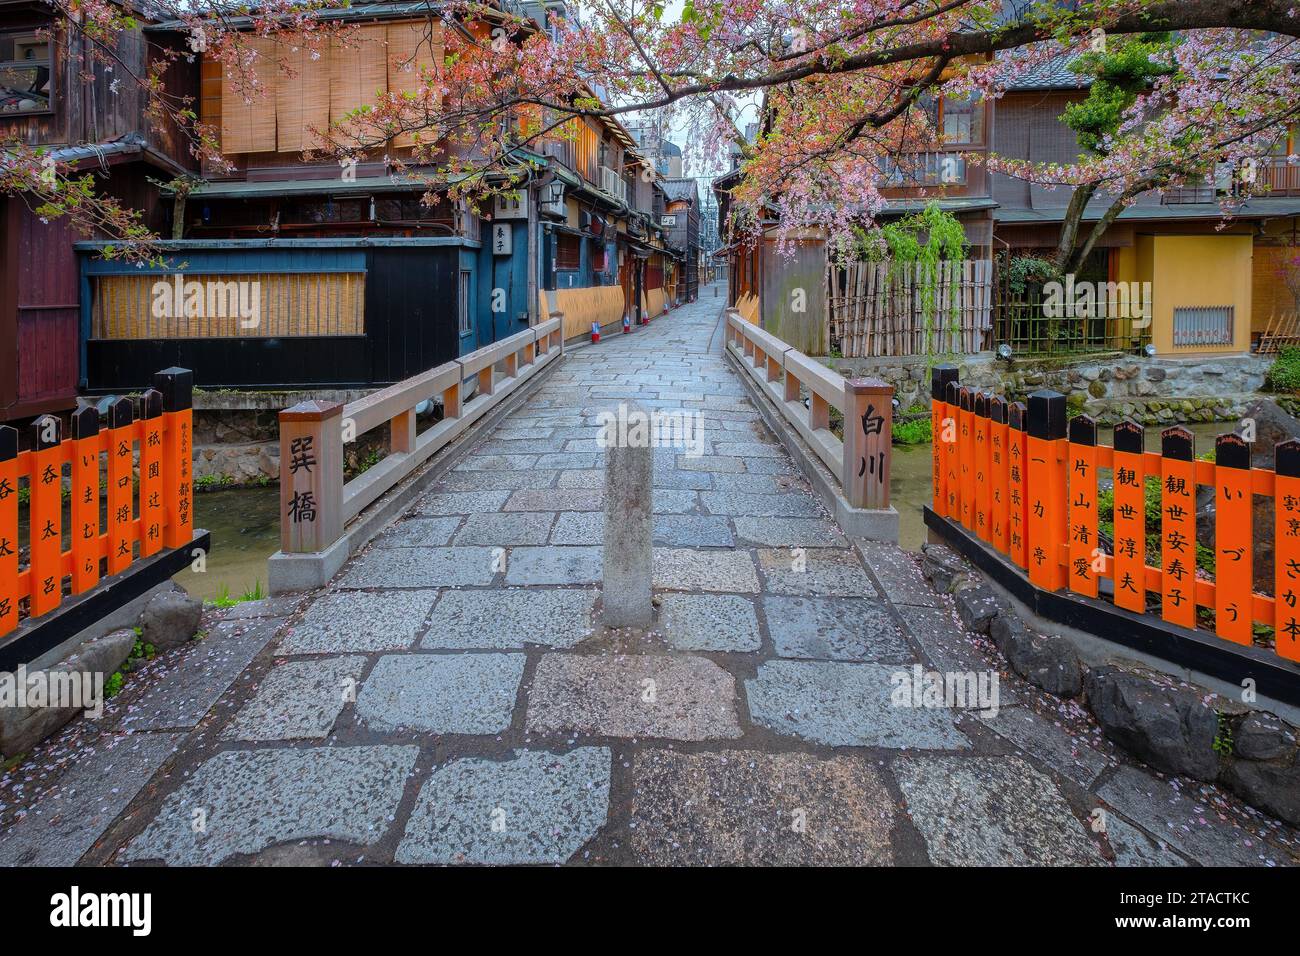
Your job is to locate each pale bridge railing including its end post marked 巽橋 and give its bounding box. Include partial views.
[280,313,564,554]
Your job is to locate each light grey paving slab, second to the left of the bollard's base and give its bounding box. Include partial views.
[277,591,438,654]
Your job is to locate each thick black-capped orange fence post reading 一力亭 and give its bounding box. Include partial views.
[1026,389,1066,591]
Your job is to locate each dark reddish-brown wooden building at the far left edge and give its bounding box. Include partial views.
[0,0,198,420]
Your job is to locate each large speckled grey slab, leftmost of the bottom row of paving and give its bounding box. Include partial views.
[122,747,419,866]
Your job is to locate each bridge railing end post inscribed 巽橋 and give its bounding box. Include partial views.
[280,401,343,554]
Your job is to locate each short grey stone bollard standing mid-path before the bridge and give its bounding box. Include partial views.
[601,402,654,627]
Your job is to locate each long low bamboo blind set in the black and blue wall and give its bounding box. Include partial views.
[91,272,365,339]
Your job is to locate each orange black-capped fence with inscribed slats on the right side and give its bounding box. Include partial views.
[931,365,1300,661]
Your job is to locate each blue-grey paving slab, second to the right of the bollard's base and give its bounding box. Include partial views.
[763,594,915,663]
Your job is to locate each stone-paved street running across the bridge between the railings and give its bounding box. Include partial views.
[0,287,1297,865]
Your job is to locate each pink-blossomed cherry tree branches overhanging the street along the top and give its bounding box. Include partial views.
[0,0,1300,254]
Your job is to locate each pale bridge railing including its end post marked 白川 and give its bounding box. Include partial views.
[725,308,893,509]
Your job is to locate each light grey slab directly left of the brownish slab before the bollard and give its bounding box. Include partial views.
[356,654,524,734]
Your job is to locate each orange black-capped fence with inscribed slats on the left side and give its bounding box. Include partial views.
[0,368,194,636]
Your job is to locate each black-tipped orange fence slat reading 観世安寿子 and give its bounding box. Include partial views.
[1160,425,1196,627]
